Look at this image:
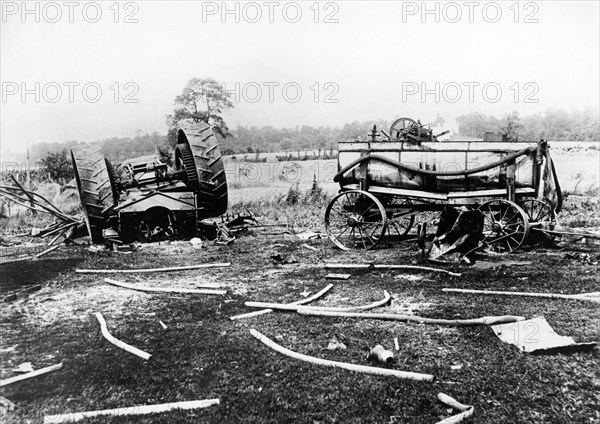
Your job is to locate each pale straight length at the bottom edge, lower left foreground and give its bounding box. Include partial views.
[44,399,219,424]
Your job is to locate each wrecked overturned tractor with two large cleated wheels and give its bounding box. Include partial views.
[71,122,227,243]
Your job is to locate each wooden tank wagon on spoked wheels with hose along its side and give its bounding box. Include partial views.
[325,118,562,253]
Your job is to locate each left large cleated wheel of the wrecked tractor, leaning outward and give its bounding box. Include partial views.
[71,146,118,243]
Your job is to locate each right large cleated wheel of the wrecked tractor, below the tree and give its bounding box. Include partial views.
[175,121,227,219]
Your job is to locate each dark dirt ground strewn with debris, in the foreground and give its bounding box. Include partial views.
[0,220,600,424]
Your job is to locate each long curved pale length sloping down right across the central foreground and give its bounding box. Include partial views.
[250,329,435,382]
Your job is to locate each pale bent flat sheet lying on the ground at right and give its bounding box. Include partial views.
[492,316,598,354]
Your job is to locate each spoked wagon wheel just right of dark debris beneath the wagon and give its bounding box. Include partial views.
[479,199,529,253]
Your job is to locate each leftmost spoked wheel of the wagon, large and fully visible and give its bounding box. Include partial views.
[325,190,388,250]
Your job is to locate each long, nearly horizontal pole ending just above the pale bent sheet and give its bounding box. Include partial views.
[298,308,525,327]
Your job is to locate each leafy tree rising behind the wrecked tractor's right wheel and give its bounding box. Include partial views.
[167,78,233,146]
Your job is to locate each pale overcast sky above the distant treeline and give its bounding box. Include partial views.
[0,1,600,156]
